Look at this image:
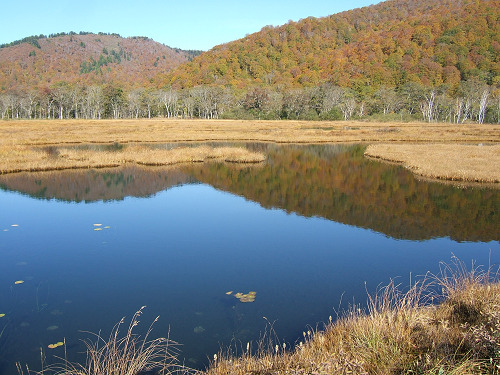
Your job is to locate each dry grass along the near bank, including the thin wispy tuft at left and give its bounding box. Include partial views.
[34,261,500,375]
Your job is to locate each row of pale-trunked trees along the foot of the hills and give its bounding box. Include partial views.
[0,80,500,123]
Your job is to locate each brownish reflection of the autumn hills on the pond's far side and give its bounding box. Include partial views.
[0,144,500,242]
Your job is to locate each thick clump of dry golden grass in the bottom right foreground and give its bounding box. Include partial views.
[206,263,500,375]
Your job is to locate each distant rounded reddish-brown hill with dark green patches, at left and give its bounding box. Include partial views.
[0,32,200,91]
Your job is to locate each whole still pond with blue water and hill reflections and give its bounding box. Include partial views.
[0,144,500,375]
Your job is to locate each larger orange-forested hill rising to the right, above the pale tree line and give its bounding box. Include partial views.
[159,0,500,93]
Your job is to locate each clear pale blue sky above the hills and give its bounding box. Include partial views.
[0,0,379,50]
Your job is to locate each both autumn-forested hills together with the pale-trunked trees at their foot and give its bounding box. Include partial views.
[0,0,500,123]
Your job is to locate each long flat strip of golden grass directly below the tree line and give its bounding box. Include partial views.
[0,119,500,146]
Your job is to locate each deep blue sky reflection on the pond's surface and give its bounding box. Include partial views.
[0,144,500,374]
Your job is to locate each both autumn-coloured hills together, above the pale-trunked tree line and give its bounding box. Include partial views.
[0,0,500,95]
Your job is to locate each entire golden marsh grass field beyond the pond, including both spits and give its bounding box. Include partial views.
[0,119,500,182]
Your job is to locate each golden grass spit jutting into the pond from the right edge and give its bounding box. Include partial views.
[365,144,500,183]
